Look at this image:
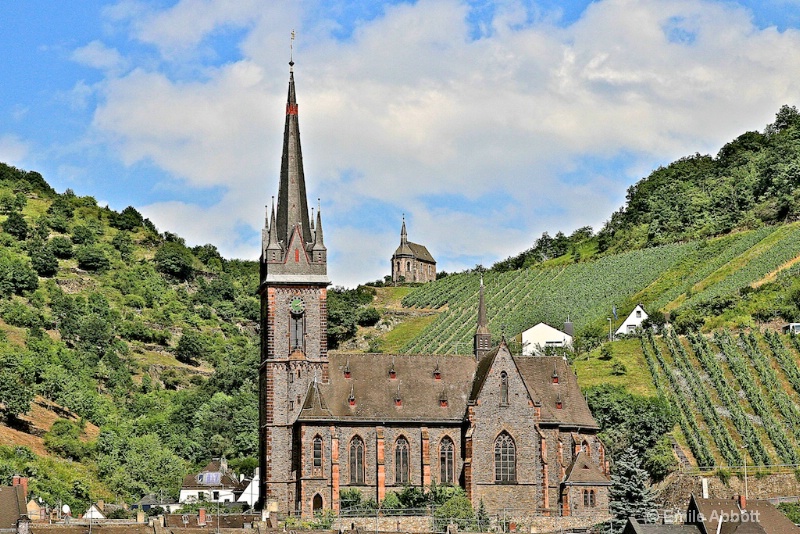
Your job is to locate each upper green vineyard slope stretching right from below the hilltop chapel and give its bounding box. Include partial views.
[403,223,800,354]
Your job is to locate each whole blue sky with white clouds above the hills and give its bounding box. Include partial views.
[0,0,800,286]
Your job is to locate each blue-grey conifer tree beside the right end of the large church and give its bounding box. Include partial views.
[609,447,655,532]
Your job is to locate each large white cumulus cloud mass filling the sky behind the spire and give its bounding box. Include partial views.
[84,0,800,284]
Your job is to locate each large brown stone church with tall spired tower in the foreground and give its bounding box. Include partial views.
[258,62,610,516]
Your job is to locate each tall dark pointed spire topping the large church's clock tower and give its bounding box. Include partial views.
[277,62,312,247]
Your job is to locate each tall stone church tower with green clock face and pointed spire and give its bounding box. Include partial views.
[258,62,330,508]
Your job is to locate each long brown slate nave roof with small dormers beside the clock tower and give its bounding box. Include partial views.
[298,353,476,423]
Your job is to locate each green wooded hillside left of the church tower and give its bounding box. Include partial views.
[0,164,259,512]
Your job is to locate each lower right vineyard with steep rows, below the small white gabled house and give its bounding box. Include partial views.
[642,331,800,467]
